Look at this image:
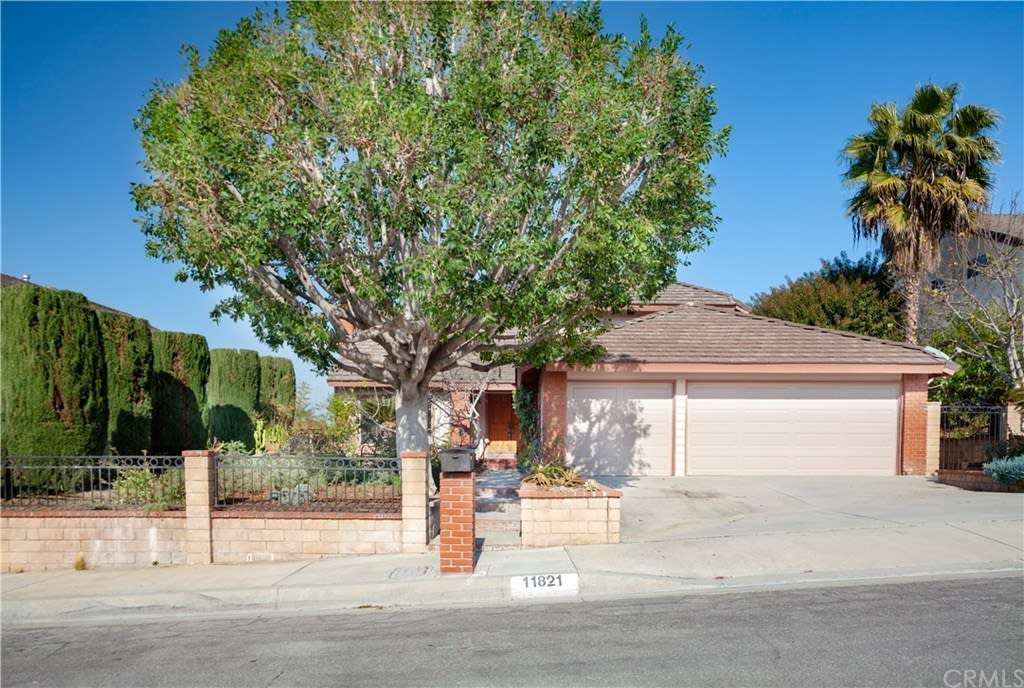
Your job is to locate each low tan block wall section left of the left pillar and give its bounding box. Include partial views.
[0,511,186,571]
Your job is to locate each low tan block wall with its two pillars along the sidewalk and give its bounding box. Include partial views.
[0,450,419,571]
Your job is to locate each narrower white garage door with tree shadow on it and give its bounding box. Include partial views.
[565,382,673,475]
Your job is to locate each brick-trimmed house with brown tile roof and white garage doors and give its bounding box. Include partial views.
[330,284,953,475]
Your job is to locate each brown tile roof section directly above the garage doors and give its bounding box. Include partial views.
[597,306,942,366]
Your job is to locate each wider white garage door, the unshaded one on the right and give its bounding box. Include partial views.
[686,382,899,475]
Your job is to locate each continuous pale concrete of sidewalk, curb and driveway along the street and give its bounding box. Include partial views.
[0,479,1024,625]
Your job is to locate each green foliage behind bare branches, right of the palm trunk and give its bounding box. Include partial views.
[926,321,1011,406]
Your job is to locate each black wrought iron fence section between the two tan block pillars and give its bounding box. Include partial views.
[217,456,401,513]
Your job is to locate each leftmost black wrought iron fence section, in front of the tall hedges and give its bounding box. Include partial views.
[0,457,185,511]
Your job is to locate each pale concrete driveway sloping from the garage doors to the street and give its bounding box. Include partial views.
[570,477,1024,590]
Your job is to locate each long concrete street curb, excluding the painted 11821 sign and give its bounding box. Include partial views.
[2,561,1024,626]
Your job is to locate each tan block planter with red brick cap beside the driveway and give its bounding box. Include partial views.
[519,483,623,547]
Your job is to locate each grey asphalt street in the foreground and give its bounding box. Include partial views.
[0,575,1024,688]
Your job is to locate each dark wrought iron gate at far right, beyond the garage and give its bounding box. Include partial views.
[939,404,1009,469]
